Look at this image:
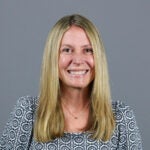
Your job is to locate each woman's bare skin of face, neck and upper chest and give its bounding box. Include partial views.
[59,26,94,132]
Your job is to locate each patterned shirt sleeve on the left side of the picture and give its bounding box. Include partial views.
[0,96,35,150]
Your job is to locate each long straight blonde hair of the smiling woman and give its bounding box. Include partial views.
[34,14,115,142]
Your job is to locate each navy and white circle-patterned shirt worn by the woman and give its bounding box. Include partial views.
[0,96,142,150]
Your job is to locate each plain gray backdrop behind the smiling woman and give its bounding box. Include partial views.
[0,0,150,149]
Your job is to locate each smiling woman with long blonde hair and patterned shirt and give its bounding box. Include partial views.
[0,14,142,150]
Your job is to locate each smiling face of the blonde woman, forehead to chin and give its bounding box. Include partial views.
[59,26,94,89]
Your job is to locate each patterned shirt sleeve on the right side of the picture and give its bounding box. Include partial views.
[116,102,142,150]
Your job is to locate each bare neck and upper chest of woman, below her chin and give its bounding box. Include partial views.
[61,86,89,132]
